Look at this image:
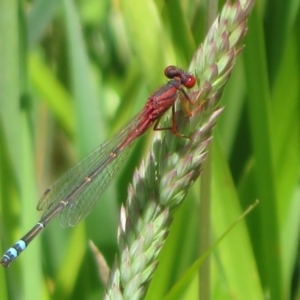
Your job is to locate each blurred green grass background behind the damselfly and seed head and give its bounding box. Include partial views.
[0,0,300,300]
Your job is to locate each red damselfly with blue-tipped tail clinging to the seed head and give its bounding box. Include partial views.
[0,66,196,267]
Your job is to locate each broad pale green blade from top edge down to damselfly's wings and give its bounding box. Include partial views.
[64,0,103,156]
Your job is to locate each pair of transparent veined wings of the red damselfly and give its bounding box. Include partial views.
[37,114,142,227]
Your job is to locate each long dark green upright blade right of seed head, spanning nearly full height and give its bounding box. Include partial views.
[245,10,284,299]
